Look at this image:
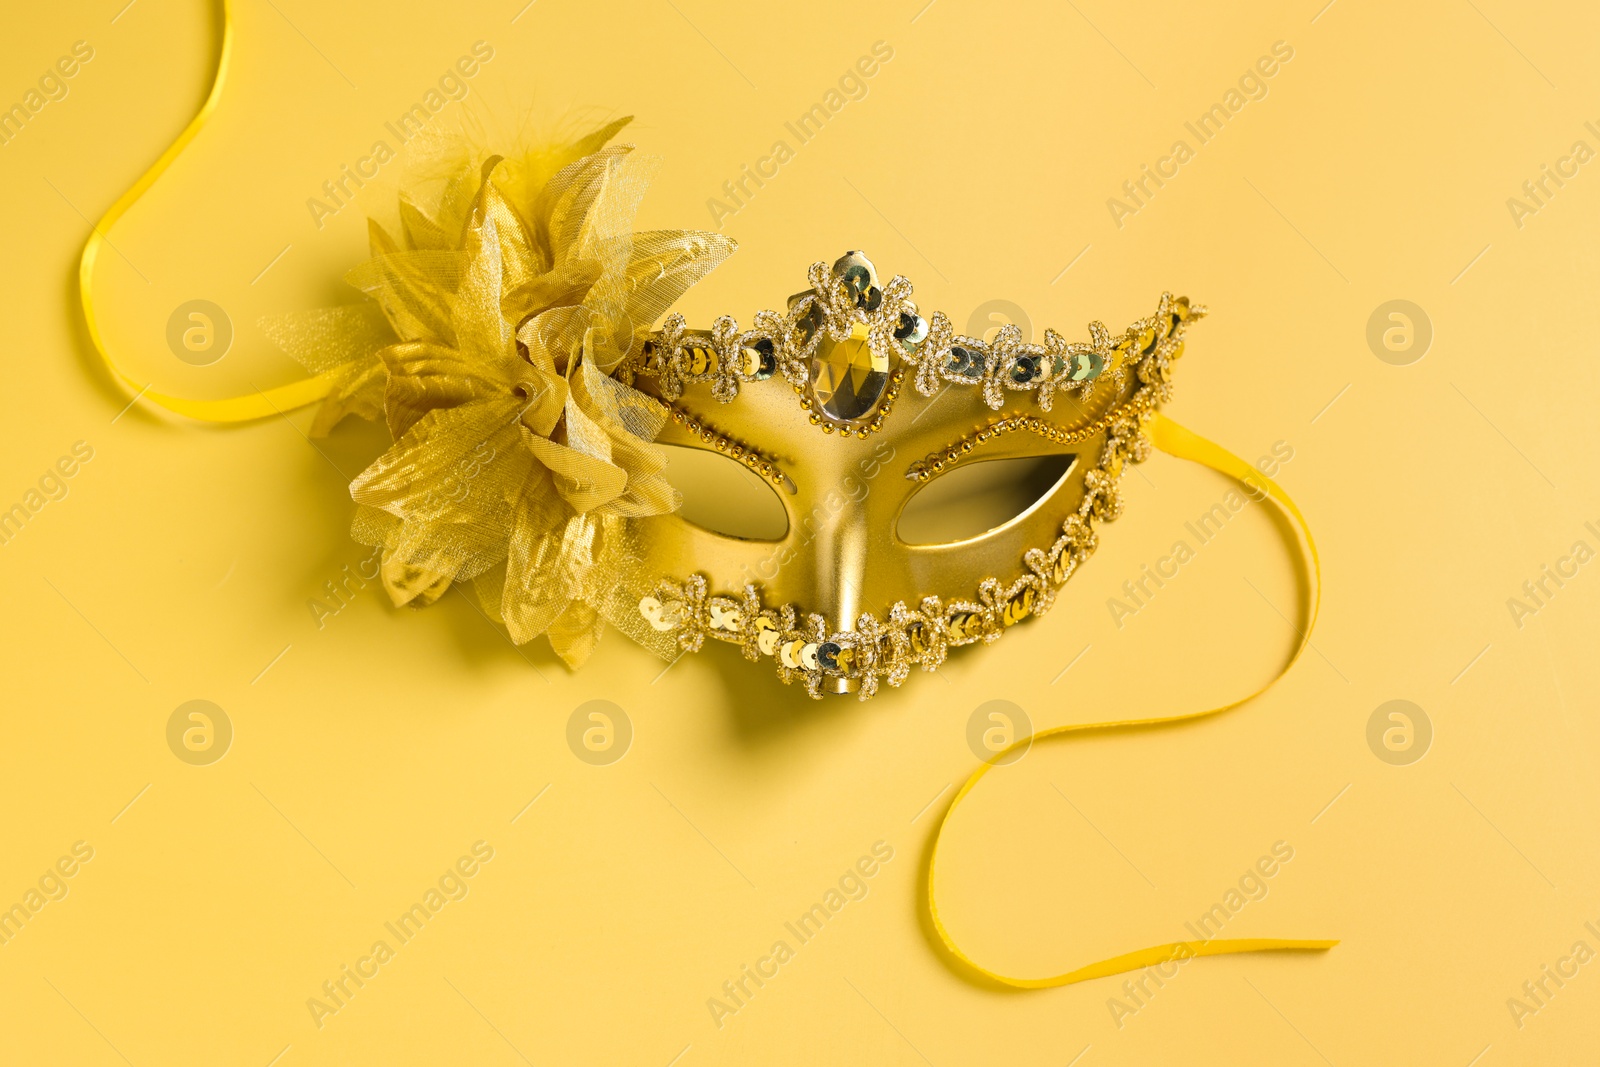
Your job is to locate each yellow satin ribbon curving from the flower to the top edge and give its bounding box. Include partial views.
[78,0,338,422]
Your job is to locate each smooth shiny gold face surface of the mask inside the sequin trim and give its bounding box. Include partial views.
[640,307,1165,693]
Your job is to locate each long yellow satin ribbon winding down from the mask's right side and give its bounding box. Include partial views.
[928,406,1339,989]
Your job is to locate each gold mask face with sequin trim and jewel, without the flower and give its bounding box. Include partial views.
[621,251,1203,699]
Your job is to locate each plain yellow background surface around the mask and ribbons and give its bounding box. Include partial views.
[0,0,1600,1067]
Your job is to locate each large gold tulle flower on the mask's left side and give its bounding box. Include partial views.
[262,118,733,667]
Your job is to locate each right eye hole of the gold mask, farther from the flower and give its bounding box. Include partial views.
[896,454,1078,544]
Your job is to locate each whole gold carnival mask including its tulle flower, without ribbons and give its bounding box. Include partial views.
[240,120,1203,699]
